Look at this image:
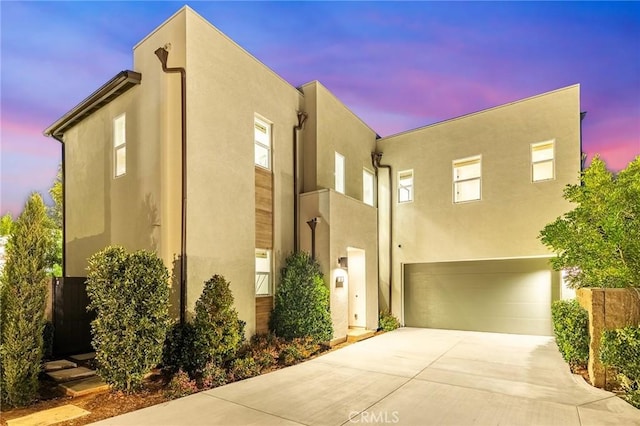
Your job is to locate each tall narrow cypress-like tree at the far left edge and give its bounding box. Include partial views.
[0,193,51,406]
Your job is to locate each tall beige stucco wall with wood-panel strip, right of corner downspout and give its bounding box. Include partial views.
[174,8,302,335]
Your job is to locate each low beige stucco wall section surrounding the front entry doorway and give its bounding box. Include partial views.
[300,189,378,339]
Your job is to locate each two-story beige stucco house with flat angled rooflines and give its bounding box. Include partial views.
[45,7,581,341]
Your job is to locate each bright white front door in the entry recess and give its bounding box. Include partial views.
[347,247,367,327]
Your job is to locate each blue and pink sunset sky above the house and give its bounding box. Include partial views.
[0,1,640,216]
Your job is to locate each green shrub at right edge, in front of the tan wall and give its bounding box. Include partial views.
[600,326,640,408]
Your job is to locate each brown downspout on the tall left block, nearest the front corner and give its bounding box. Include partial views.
[154,46,187,325]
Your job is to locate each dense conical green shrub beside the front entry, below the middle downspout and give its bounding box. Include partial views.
[269,252,333,342]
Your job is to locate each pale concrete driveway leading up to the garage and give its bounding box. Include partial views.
[92,328,640,426]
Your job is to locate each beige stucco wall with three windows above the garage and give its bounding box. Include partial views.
[378,85,580,314]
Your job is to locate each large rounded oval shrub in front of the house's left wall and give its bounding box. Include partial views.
[87,247,169,392]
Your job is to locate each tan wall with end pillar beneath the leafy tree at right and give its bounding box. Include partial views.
[576,288,640,388]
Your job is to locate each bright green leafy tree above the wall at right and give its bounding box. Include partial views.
[540,156,640,288]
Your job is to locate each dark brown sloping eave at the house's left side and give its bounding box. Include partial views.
[44,70,142,142]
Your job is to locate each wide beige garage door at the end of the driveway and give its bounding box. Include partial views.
[404,259,558,335]
